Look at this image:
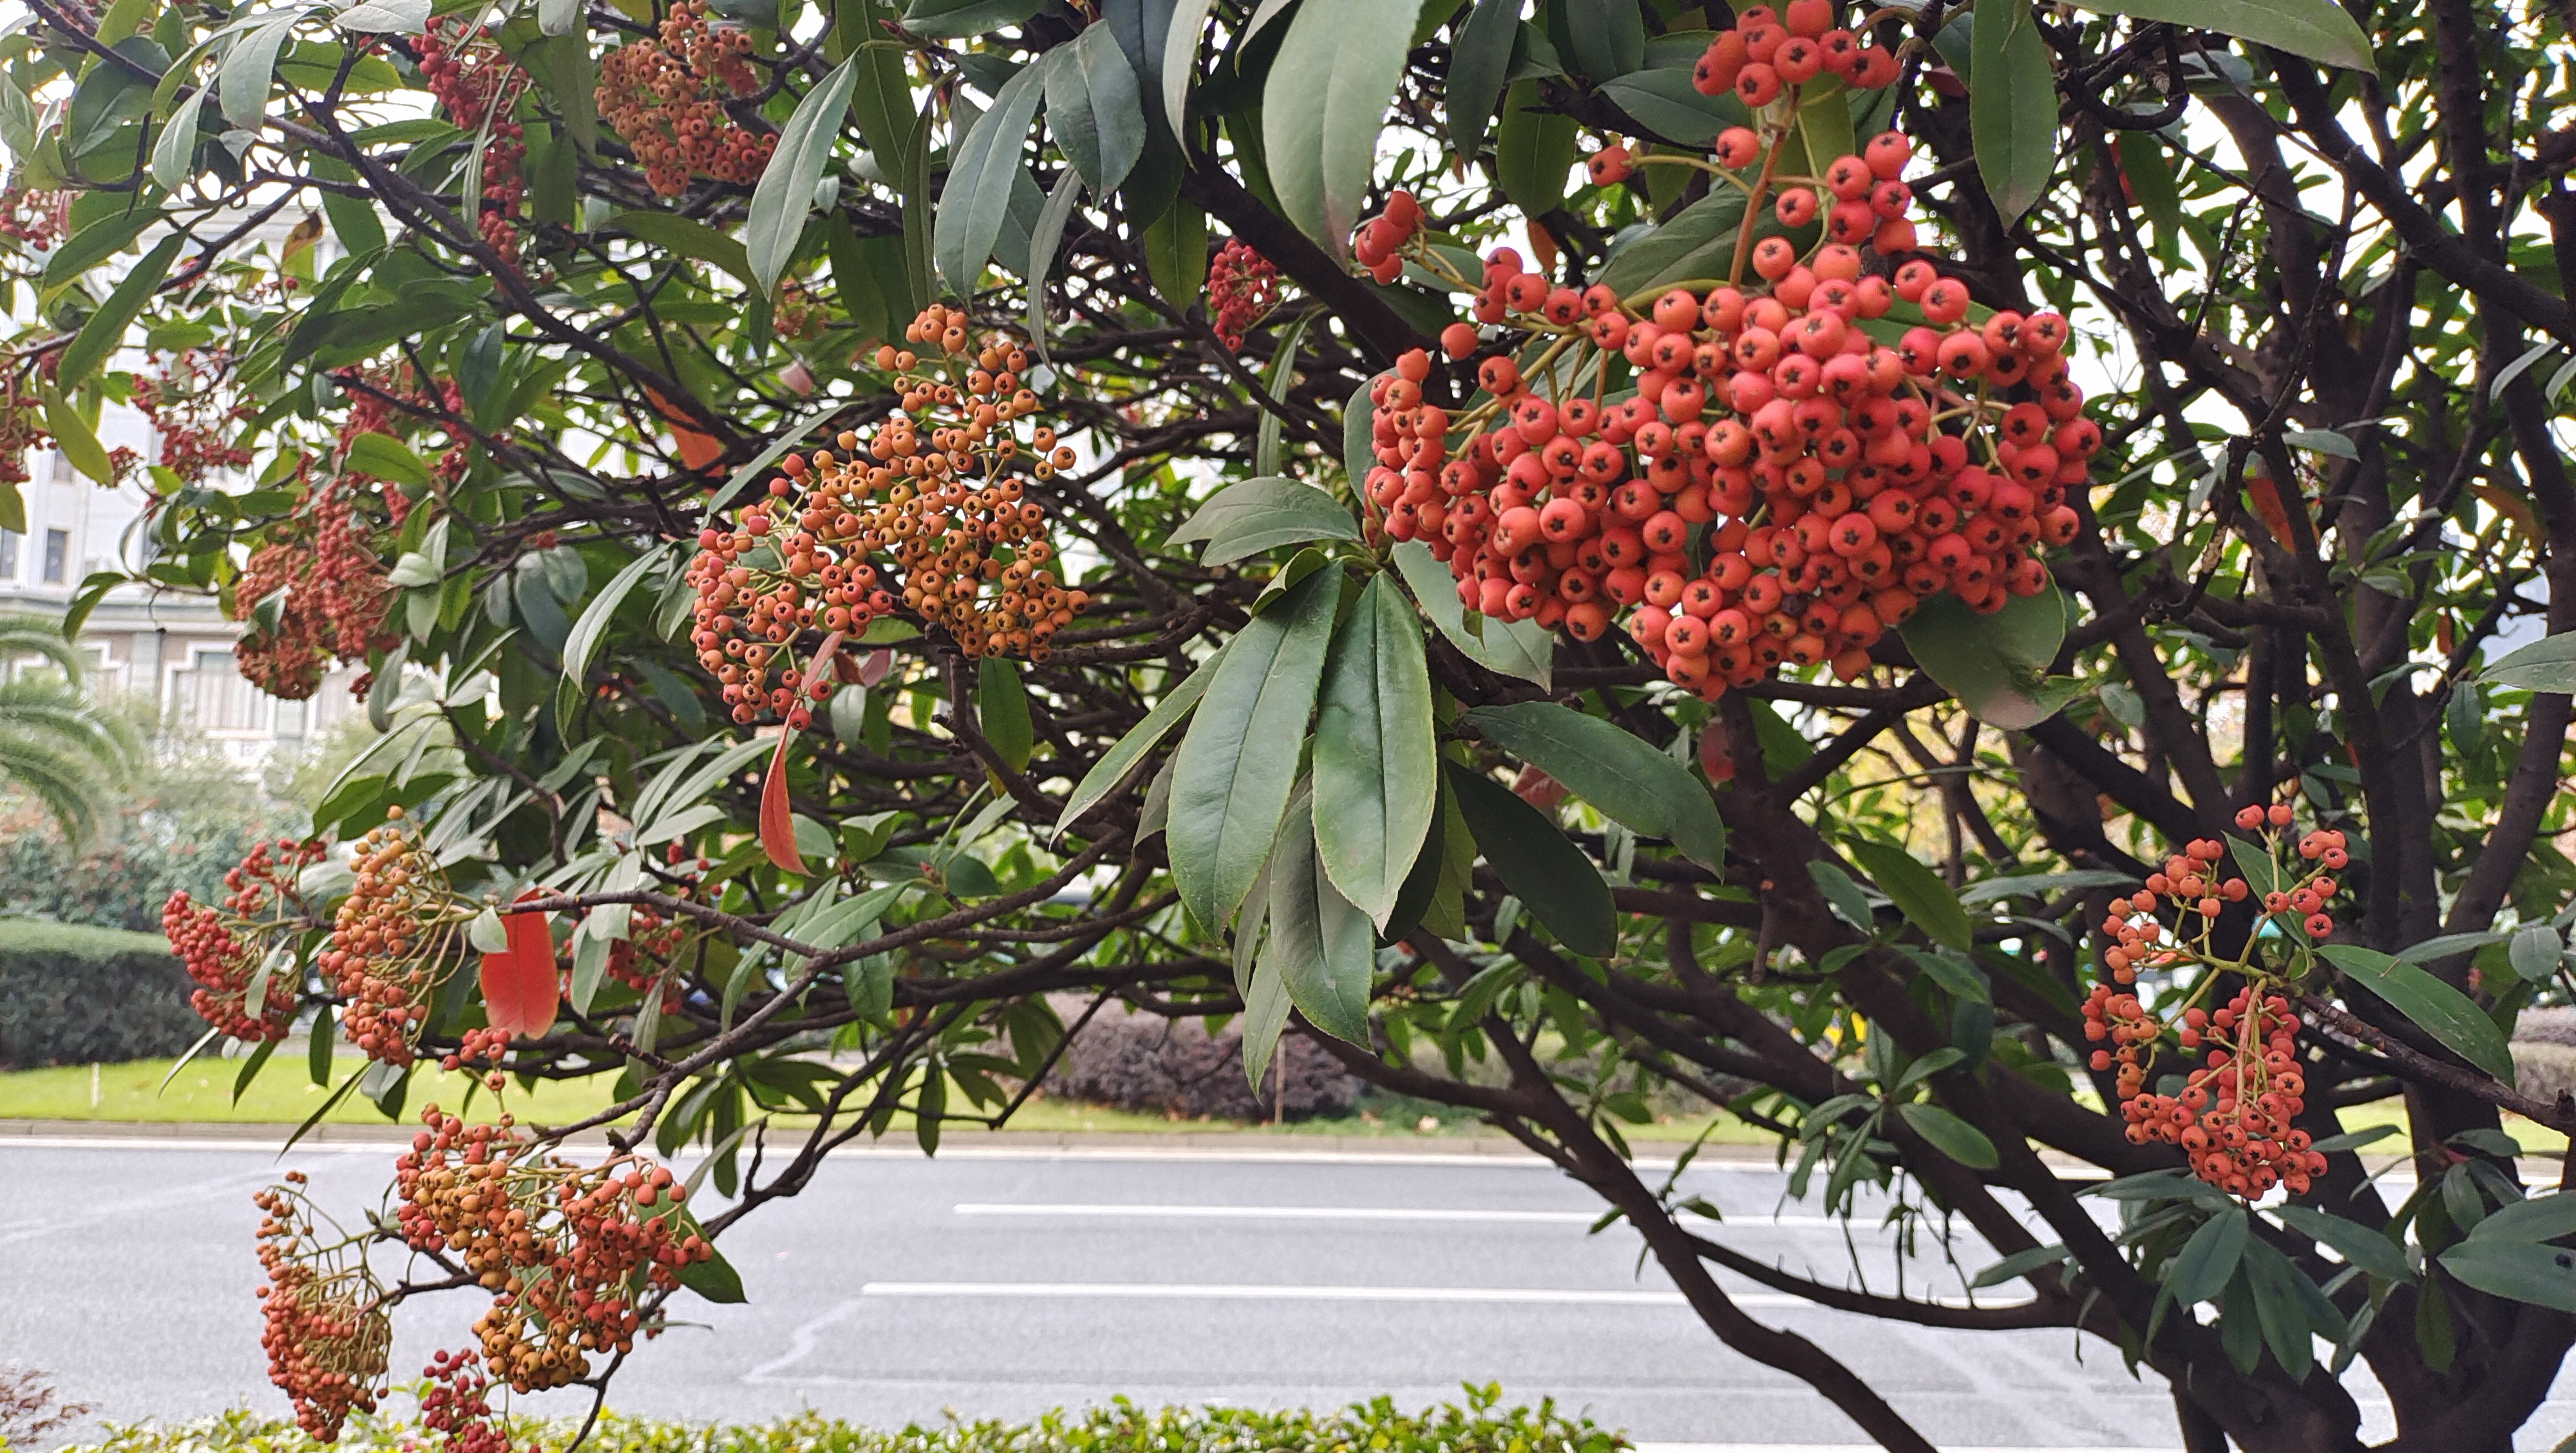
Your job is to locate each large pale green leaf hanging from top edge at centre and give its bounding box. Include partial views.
[1262,0,1422,260]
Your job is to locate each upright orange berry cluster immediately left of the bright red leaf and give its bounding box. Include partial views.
[322,806,464,1064]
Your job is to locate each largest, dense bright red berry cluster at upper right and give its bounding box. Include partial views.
[1363,5,2102,698]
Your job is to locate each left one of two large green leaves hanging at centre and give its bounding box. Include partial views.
[1164,569,1342,933]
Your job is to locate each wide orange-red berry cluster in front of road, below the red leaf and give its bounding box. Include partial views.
[394,1105,716,1391]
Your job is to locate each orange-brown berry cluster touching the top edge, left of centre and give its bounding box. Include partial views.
[598,0,778,196]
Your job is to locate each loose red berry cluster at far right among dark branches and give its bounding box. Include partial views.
[2084,804,2349,1195]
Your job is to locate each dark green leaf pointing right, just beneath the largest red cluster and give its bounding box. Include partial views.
[1466,701,1726,873]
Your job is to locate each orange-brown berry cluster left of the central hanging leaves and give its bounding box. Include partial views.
[688,307,1090,726]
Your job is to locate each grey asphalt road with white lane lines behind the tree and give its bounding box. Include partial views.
[0,1141,2576,1453]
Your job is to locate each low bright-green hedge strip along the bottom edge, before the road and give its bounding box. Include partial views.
[67,1386,1631,1453]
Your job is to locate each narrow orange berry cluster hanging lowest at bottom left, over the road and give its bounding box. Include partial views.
[252,1170,394,1443]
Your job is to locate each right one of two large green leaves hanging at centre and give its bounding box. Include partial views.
[1309,575,1440,927]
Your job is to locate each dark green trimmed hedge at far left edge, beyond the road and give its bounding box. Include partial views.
[0,917,206,1069]
